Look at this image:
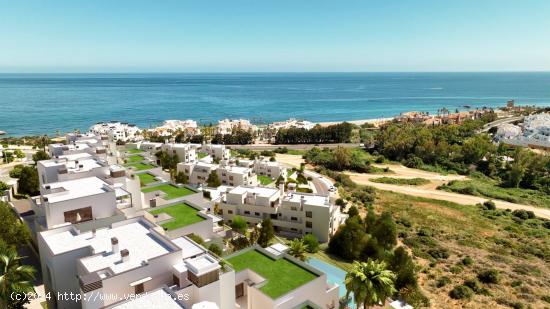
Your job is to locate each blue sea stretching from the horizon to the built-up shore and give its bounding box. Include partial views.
[0,72,550,136]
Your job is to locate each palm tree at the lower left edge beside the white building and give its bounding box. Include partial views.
[0,245,35,308]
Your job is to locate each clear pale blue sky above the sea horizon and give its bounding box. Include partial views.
[0,0,550,72]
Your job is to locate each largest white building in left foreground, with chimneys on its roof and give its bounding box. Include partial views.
[38,217,235,309]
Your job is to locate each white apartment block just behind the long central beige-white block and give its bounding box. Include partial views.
[177,161,258,186]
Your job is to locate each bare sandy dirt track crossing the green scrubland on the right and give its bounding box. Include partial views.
[346,164,550,219]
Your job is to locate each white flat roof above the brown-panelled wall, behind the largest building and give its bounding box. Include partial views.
[43,177,109,203]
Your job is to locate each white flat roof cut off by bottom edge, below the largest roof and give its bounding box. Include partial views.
[108,289,185,309]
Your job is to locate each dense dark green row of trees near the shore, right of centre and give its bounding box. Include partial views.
[275,122,353,144]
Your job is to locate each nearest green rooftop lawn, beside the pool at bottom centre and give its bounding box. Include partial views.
[227,250,318,299]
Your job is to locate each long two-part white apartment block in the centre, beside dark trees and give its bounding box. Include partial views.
[219,186,344,242]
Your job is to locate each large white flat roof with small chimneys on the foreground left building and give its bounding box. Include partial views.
[43,221,172,274]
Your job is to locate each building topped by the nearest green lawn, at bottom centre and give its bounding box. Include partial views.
[226,246,339,309]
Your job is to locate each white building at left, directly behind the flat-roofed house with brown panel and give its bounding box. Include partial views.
[36,152,109,185]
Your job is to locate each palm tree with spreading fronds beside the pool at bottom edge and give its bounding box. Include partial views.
[344,259,396,309]
